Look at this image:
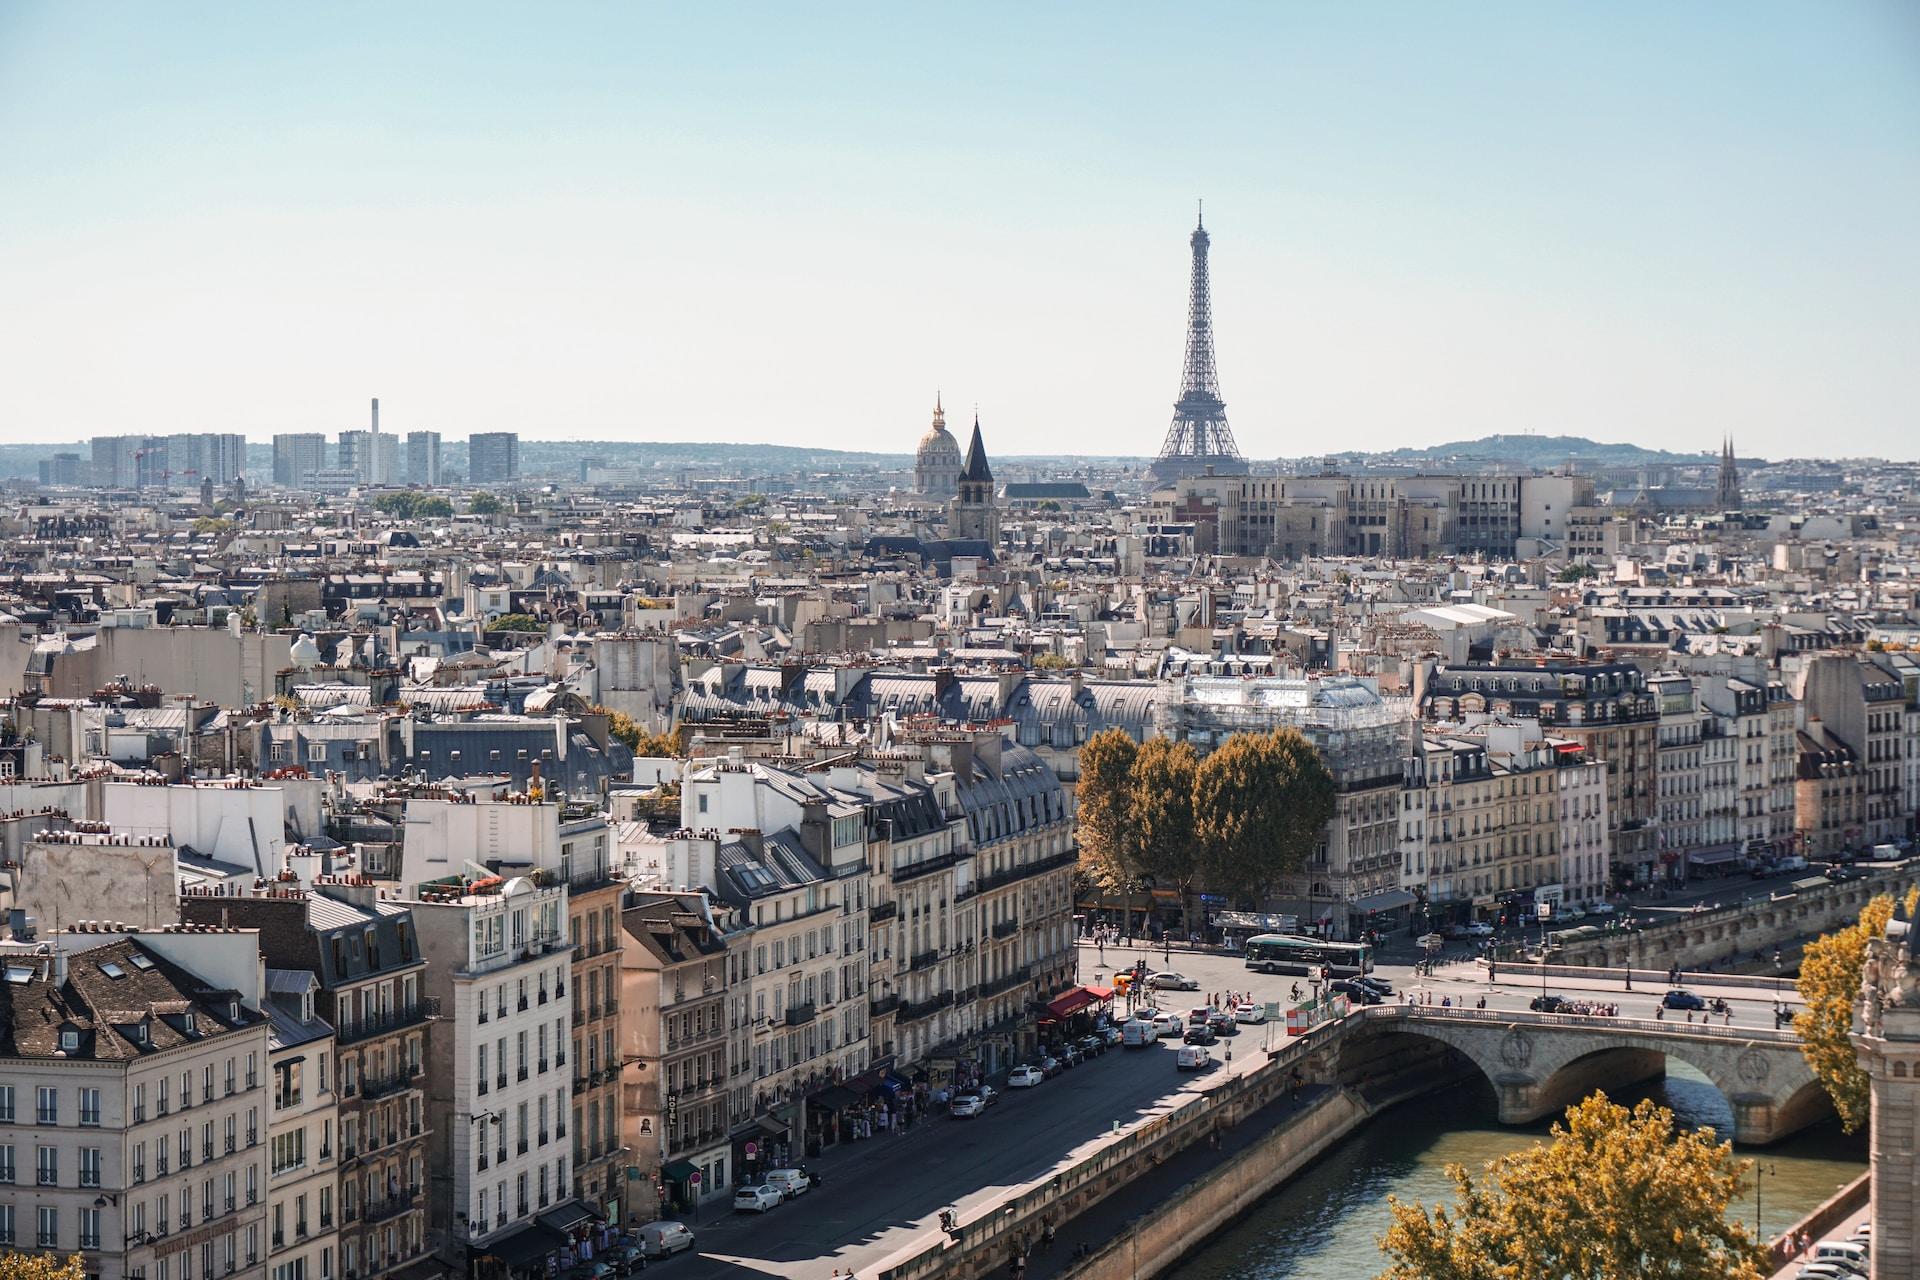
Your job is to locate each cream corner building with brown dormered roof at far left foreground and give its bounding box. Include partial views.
[0,925,269,1280]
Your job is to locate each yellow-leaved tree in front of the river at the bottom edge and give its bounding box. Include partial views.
[1379,1094,1766,1280]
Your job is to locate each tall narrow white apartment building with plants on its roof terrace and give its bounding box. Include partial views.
[411,871,576,1267]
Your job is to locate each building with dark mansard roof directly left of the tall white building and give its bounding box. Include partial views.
[180,877,434,1280]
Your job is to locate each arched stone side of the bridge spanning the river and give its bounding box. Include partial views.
[1336,1006,1832,1146]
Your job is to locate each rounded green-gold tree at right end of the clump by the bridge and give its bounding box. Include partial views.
[1194,729,1334,906]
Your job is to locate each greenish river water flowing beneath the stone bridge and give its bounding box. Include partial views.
[1169,1063,1866,1280]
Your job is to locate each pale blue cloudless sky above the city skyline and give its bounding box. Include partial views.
[0,0,1920,457]
